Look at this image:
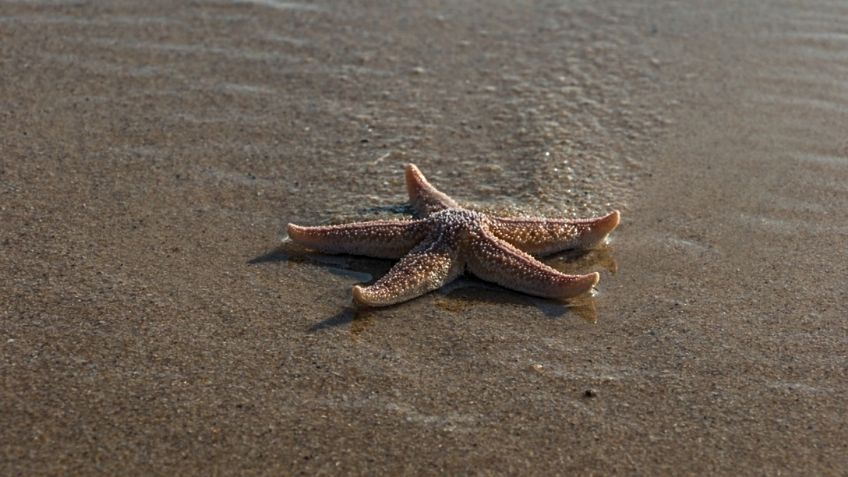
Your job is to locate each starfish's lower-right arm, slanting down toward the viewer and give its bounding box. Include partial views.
[466,226,599,299]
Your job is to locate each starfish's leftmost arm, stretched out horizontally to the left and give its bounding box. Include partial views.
[288,220,427,258]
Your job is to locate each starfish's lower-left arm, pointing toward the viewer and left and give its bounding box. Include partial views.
[353,233,463,306]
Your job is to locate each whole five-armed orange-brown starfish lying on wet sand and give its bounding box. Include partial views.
[288,164,619,306]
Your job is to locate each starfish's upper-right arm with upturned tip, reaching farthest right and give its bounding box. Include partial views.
[489,210,620,255]
